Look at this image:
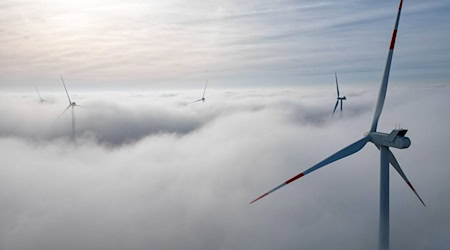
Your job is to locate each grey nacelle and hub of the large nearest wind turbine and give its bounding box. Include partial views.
[367,129,411,149]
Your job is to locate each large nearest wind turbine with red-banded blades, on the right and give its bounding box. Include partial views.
[250,0,425,250]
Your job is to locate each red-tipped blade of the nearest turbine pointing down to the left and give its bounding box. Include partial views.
[250,136,369,204]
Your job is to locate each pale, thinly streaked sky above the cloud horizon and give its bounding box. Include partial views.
[0,0,450,91]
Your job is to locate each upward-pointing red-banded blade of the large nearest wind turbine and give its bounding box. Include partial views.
[370,0,403,132]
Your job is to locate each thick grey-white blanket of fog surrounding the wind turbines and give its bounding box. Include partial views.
[0,87,450,250]
